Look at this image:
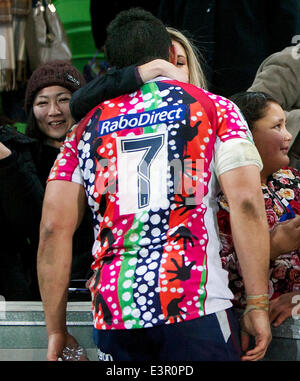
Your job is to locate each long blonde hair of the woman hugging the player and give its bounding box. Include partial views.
[167,27,207,90]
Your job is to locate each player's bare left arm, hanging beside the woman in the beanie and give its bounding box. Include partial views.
[38,181,86,360]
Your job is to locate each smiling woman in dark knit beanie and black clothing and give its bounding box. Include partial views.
[25,61,94,290]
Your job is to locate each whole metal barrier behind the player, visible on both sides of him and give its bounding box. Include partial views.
[0,300,300,361]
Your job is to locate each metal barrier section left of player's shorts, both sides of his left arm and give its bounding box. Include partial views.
[0,302,98,361]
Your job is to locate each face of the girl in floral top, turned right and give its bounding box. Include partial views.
[252,102,292,177]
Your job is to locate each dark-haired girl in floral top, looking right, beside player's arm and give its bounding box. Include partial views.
[218,92,300,326]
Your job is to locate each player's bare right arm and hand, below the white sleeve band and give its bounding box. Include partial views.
[219,165,271,360]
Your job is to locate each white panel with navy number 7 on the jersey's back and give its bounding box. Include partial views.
[117,133,168,214]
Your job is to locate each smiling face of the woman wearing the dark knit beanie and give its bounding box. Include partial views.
[33,86,74,146]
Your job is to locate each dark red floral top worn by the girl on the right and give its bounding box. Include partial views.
[217,168,300,308]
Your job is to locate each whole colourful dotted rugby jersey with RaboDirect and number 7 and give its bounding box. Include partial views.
[49,79,257,329]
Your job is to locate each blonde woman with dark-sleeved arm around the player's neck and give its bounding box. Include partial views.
[70,27,207,121]
